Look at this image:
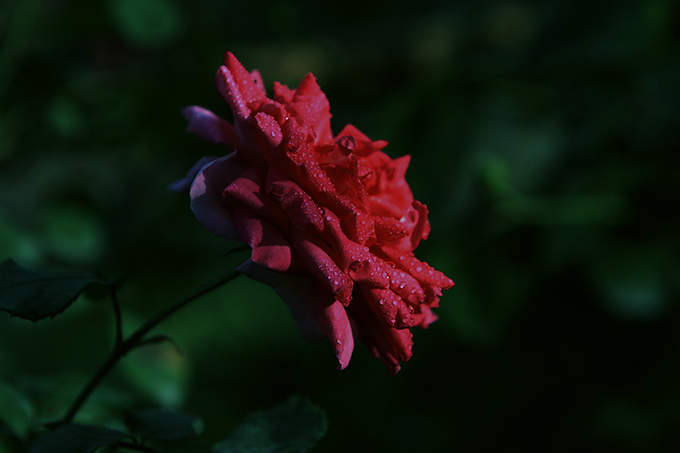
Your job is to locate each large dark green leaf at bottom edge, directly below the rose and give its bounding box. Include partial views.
[213,396,328,453]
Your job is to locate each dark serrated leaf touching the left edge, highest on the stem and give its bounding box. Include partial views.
[0,259,106,322]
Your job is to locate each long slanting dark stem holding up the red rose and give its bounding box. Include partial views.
[55,272,241,428]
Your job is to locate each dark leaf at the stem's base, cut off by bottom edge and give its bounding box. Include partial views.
[28,425,126,453]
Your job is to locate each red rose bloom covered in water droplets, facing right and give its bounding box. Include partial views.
[171,53,453,374]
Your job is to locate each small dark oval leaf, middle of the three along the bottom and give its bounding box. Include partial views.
[125,410,203,440]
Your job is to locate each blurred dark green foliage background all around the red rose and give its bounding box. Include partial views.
[0,0,680,452]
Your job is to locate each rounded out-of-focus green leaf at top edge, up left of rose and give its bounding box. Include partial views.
[110,0,182,48]
